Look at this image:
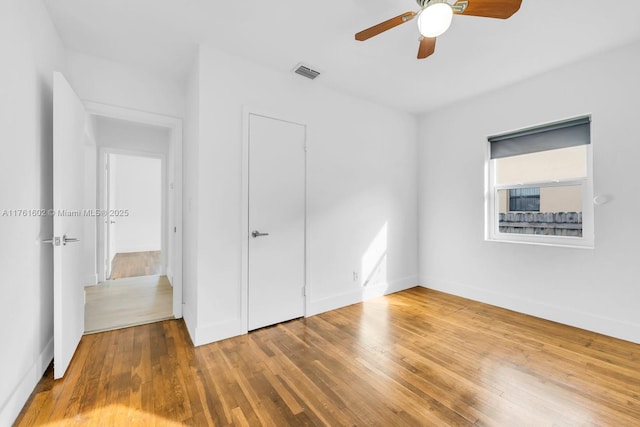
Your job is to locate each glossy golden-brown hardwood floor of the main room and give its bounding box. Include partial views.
[16,288,640,427]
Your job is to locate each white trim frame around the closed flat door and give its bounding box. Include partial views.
[240,106,311,334]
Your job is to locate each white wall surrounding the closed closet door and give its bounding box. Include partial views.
[185,47,417,344]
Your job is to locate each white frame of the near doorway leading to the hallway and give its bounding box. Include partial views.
[84,101,182,319]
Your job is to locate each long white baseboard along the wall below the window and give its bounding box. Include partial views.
[420,278,640,344]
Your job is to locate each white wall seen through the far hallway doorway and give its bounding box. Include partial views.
[110,154,162,253]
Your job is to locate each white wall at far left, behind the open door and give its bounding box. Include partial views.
[0,0,64,426]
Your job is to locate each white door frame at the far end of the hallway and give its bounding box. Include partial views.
[97,147,170,282]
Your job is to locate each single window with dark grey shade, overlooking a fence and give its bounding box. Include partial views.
[485,116,593,247]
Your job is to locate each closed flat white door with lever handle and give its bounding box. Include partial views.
[247,114,306,330]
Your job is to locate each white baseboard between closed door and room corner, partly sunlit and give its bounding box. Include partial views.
[306,276,418,317]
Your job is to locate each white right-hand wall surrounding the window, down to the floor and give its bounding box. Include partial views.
[419,40,640,342]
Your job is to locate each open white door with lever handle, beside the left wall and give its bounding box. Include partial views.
[53,73,86,379]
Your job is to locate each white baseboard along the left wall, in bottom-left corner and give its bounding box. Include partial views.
[0,337,53,426]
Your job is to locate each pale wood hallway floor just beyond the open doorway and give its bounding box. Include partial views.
[84,276,173,333]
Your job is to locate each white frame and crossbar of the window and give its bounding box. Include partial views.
[485,116,595,249]
